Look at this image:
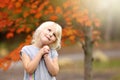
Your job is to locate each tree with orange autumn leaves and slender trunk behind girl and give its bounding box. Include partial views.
[0,0,100,80]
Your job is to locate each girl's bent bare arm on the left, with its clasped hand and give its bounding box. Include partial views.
[21,47,49,74]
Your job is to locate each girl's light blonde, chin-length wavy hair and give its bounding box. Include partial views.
[32,21,62,50]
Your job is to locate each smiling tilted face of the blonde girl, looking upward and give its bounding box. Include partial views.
[40,26,56,45]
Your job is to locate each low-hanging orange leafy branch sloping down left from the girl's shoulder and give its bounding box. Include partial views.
[0,35,31,70]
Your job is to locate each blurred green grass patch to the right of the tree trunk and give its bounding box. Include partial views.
[93,59,120,80]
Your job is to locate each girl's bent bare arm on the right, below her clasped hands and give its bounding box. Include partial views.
[44,54,59,76]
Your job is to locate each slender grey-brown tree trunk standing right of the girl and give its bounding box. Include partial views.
[84,27,93,80]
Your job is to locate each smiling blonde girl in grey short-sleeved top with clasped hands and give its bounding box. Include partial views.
[21,21,62,80]
